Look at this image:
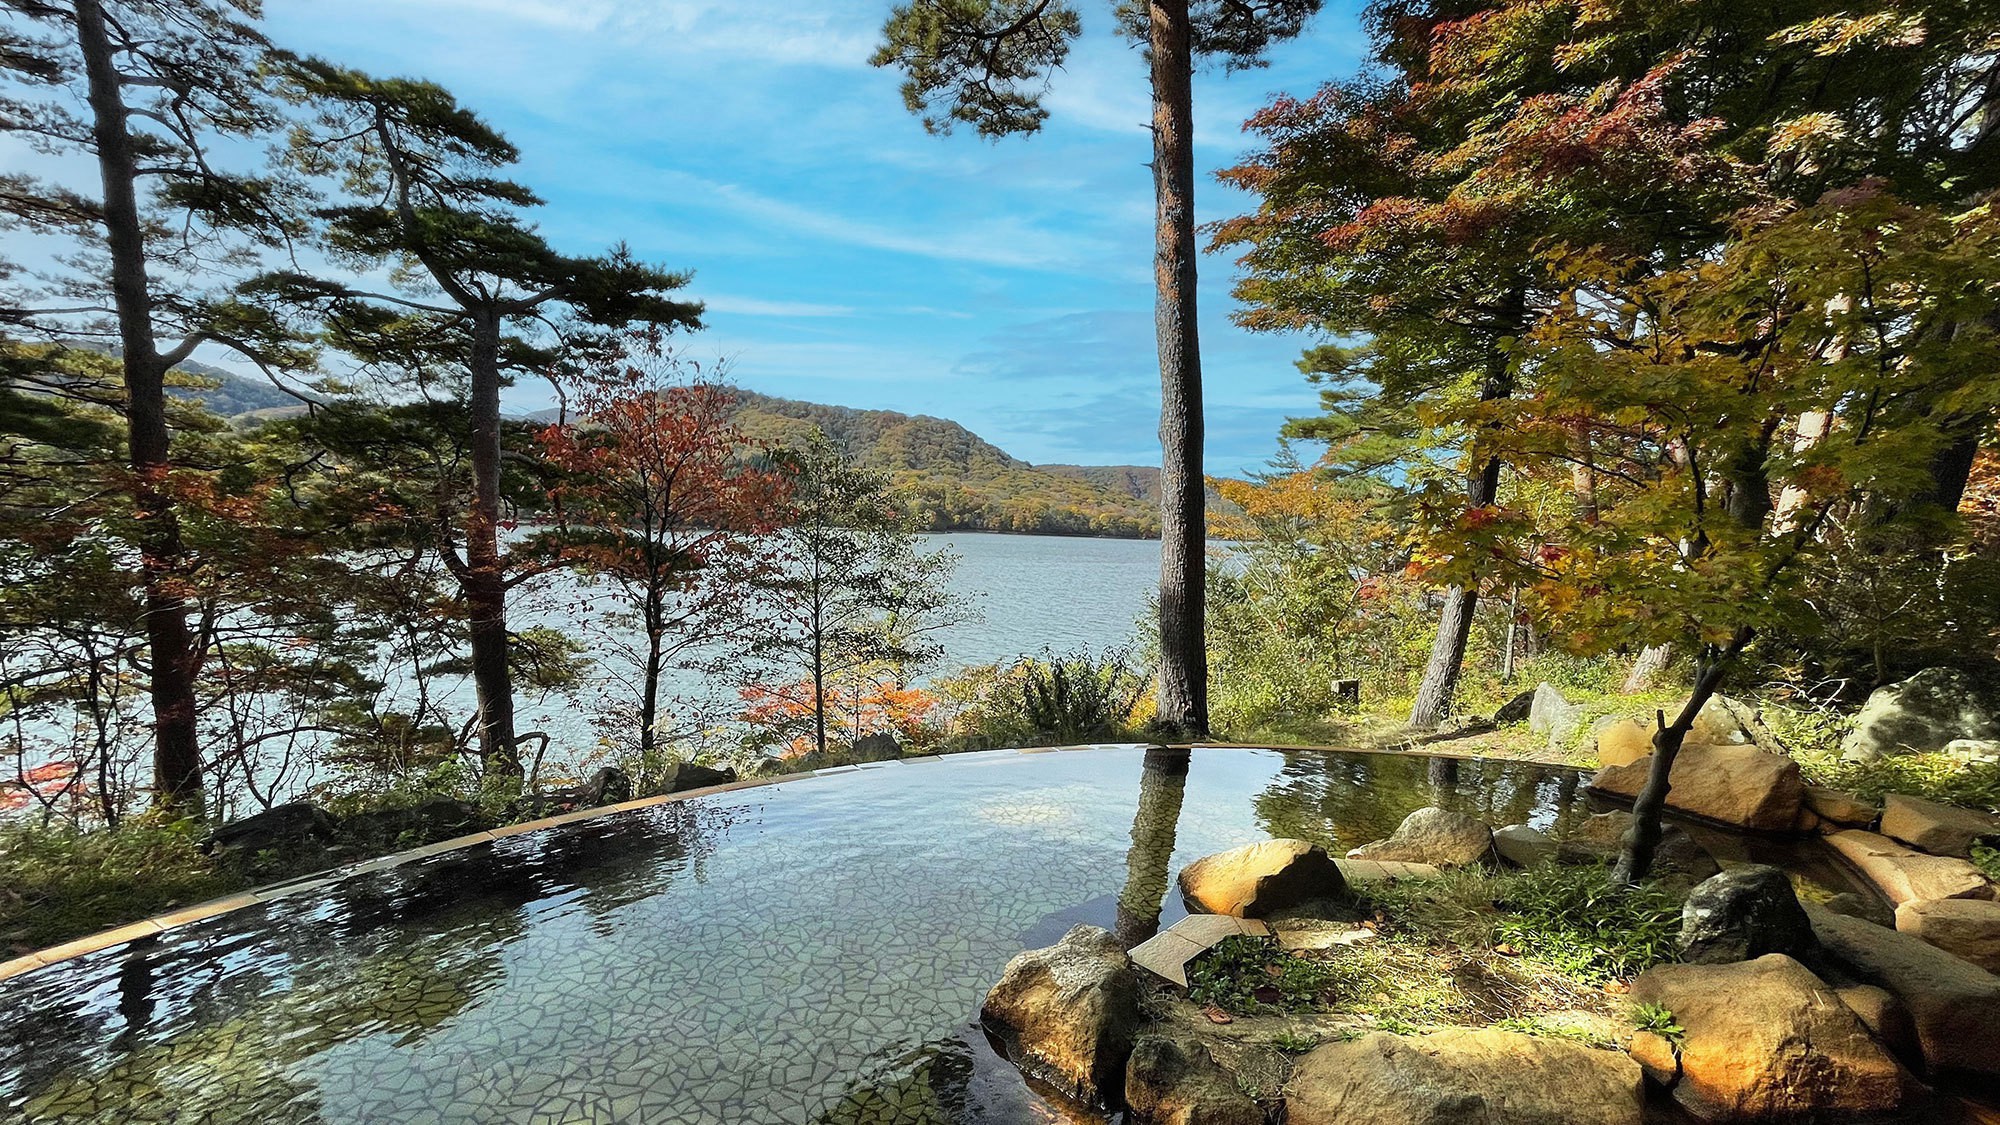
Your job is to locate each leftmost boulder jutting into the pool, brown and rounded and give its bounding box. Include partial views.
[980,925,1140,1105]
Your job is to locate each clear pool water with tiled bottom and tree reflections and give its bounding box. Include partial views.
[0,749,1848,1125]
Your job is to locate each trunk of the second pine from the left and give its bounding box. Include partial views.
[458,312,522,779]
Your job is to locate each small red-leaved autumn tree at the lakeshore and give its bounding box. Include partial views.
[540,340,786,759]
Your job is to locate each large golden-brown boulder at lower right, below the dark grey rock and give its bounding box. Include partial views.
[1632,953,1918,1121]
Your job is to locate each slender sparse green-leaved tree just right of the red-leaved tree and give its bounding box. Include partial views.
[750,430,966,753]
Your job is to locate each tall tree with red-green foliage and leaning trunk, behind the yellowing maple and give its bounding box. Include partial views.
[1216,2,1768,727]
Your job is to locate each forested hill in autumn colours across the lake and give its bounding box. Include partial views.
[736,390,1160,538]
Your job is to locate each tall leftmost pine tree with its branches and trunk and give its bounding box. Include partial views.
[0,0,306,815]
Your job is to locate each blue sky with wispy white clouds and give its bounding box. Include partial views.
[266,0,1362,472]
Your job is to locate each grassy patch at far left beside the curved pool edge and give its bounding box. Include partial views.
[0,819,248,953]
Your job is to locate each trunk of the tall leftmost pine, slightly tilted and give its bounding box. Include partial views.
[76,0,204,817]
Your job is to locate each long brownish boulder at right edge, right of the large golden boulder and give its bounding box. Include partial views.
[1806,907,2000,1081]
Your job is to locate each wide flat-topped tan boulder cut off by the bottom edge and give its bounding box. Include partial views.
[1284,1027,1644,1125]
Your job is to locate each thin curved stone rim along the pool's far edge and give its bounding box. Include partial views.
[0,743,1572,981]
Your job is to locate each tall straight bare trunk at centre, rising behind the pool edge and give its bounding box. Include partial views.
[1148,0,1208,739]
